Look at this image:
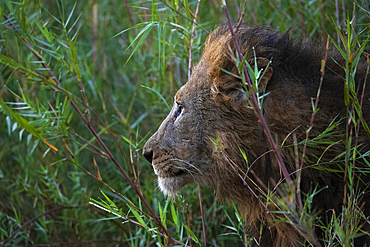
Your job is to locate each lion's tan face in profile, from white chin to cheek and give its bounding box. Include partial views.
[143,27,272,199]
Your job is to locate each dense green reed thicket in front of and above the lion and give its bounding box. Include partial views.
[0,0,370,246]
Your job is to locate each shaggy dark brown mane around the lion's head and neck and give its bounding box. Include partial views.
[202,24,370,246]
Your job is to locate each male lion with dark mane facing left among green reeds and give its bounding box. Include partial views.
[143,24,370,247]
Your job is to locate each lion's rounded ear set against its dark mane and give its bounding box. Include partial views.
[248,57,273,94]
